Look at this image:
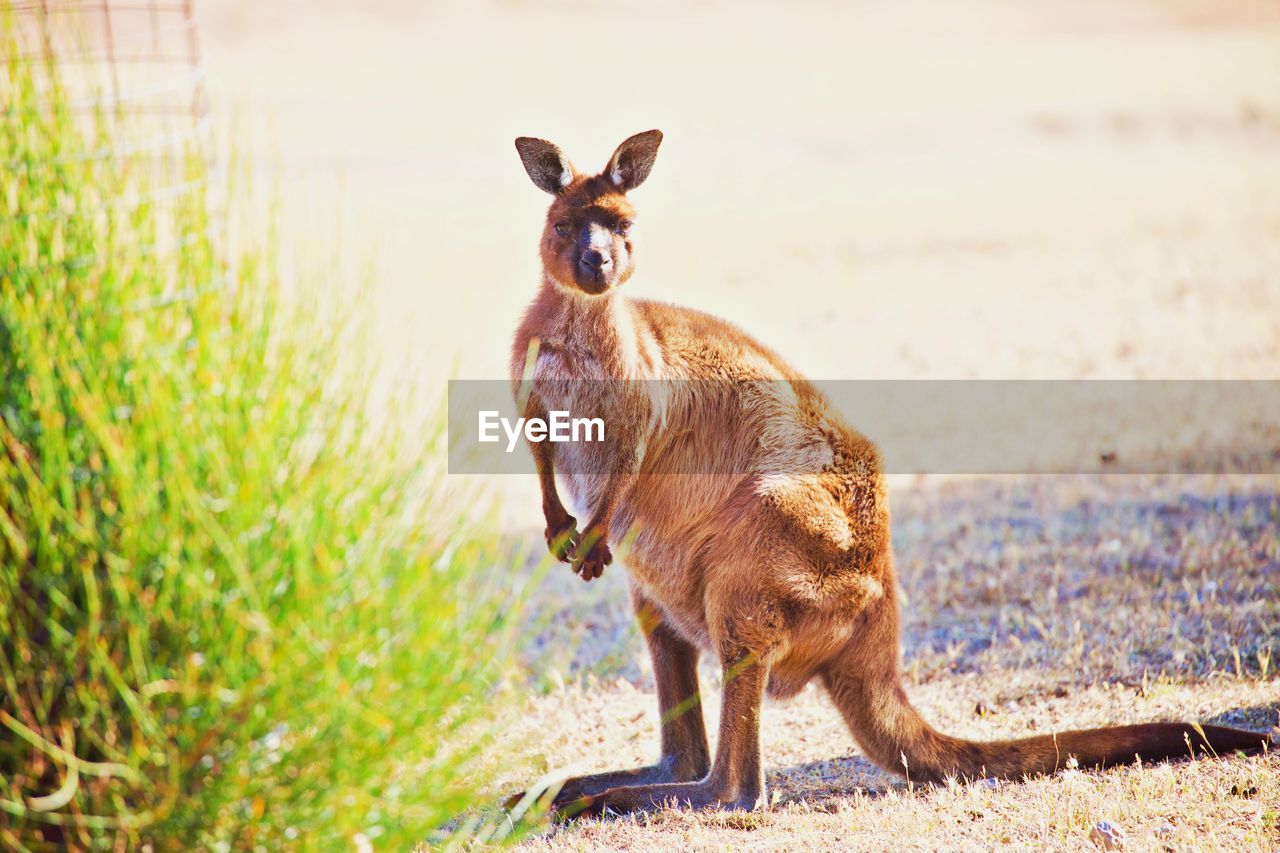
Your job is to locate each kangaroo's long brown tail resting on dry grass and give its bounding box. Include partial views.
[823,630,1272,781]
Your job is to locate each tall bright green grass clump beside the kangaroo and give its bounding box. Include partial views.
[0,29,513,849]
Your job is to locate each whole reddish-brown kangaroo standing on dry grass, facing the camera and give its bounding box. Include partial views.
[511,131,1271,816]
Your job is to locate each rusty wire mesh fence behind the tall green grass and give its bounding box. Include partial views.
[0,0,223,310]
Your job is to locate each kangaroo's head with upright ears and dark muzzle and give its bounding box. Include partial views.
[516,131,662,296]
